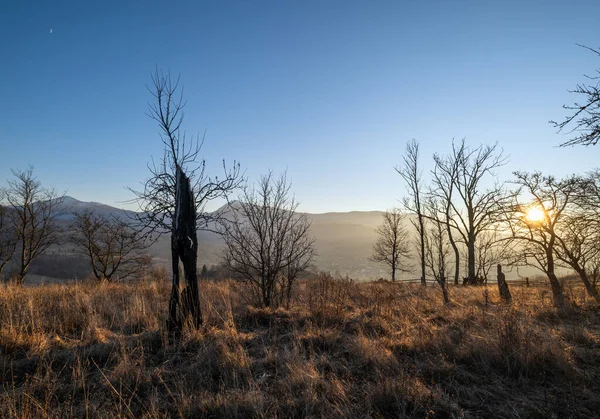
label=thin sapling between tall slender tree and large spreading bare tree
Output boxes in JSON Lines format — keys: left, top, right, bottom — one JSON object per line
{"left": 425, "top": 197, "right": 450, "bottom": 304}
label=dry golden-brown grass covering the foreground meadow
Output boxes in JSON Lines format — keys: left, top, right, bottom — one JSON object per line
{"left": 0, "top": 277, "right": 600, "bottom": 418}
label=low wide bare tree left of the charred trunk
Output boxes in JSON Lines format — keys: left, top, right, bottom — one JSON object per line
{"left": 71, "top": 210, "right": 152, "bottom": 282}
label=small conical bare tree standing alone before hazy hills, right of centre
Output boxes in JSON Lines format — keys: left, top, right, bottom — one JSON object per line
{"left": 370, "top": 208, "right": 411, "bottom": 281}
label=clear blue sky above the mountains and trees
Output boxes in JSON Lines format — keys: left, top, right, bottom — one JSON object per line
{"left": 0, "top": 0, "right": 600, "bottom": 212}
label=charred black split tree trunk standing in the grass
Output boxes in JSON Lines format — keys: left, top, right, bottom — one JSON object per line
{"left": 167, "top": 166, "right": 202, "bottom": 342}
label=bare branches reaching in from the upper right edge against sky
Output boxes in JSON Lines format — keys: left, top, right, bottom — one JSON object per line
{"left": 550, "top": 45, "right": 600, "bottom": 147}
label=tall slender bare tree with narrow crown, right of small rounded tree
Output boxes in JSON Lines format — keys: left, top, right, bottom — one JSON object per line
{"left": 395, "top": 139, "right": 427, "bottom": 285}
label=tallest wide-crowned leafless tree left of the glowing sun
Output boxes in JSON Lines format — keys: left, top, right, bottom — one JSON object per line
{"left": 439, "top": 140, "right": 508, "bottom": 284}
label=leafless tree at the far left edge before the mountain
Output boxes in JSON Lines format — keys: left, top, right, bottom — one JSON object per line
{"left": 5, "top": 167, "right": 64, "bottom": 284}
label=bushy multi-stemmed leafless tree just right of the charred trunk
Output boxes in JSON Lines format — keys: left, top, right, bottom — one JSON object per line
{"left": 222, "top": 172, "right": 315, "bottom": 307}
